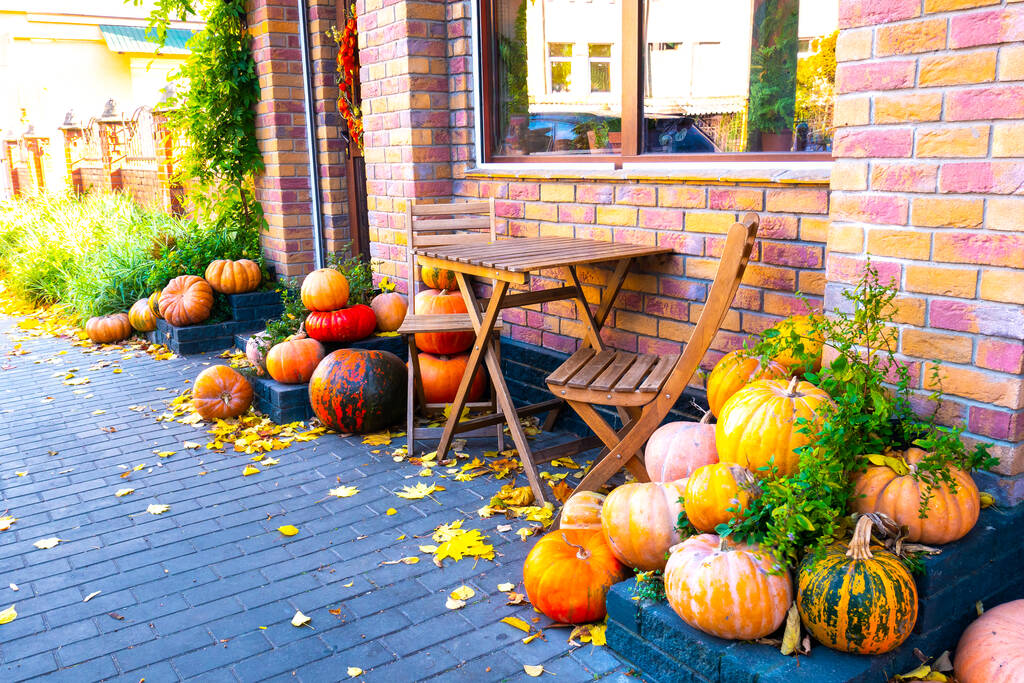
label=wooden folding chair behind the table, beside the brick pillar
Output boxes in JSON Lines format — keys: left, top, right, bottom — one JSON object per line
{"left": 398, "top": 199, "right": 505, "bottom": 456}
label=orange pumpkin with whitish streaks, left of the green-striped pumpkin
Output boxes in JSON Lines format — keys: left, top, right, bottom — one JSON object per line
{"left": 665, "top": 533, "right": 793, "bottom": 640}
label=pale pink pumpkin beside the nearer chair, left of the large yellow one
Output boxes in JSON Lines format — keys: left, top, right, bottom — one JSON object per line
{"left": 643, "top": 413, "right": 718, "bottom": 481}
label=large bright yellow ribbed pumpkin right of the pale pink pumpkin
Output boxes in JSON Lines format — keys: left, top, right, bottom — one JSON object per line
{"left": 715, "top": 377, "right": 831, "bottom": 477}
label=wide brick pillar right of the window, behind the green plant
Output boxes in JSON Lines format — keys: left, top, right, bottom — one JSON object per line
{"left": 826, "top": 0, "right": 1024, "bottom": 501}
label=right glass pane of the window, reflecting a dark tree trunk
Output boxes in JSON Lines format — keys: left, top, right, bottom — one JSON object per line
{"left": 641, "top": 0, "right": 839, "bottom": 154}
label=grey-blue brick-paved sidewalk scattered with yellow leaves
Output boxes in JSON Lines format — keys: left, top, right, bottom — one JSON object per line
{"left": 0, "top": 315, "right": 637, "bottom": 683}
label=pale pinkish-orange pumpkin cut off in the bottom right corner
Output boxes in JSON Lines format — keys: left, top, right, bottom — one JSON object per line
{"left": 953, "top": 600, "right": 1024, "bottom": 683}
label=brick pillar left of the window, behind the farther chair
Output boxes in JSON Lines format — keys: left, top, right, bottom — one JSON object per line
{"left": 356, "top": 0, "right": 452, "bottom": 292}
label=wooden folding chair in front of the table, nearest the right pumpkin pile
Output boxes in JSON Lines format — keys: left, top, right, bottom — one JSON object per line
{"left": 547, "top": 213, "right": 758, "bottom": 501}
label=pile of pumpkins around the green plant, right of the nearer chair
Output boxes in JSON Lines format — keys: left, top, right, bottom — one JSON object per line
{"left": 523, "top": 316, "right": 980, "bottom": 671}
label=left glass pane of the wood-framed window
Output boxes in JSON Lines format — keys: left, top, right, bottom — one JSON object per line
{"left": 488, "top": 0, "right": 623, "bottom": 157}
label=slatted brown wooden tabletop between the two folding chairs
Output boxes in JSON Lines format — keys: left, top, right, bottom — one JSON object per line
{"left": 415, "top": 238, "right": 672, "bottom": 272}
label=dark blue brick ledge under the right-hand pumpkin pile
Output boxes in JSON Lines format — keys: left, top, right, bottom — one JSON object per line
{"left": 607, "top": 506, "right": 1024, "bottom": 683}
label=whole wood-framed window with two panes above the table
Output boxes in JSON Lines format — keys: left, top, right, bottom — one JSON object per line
{"left": 480, "top": 0, "right": 839, "bottom": 163}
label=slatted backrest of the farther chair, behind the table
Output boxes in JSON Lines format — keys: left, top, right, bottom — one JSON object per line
{"left": 406, "top": 198, "right": 497, "bottom": 314}
